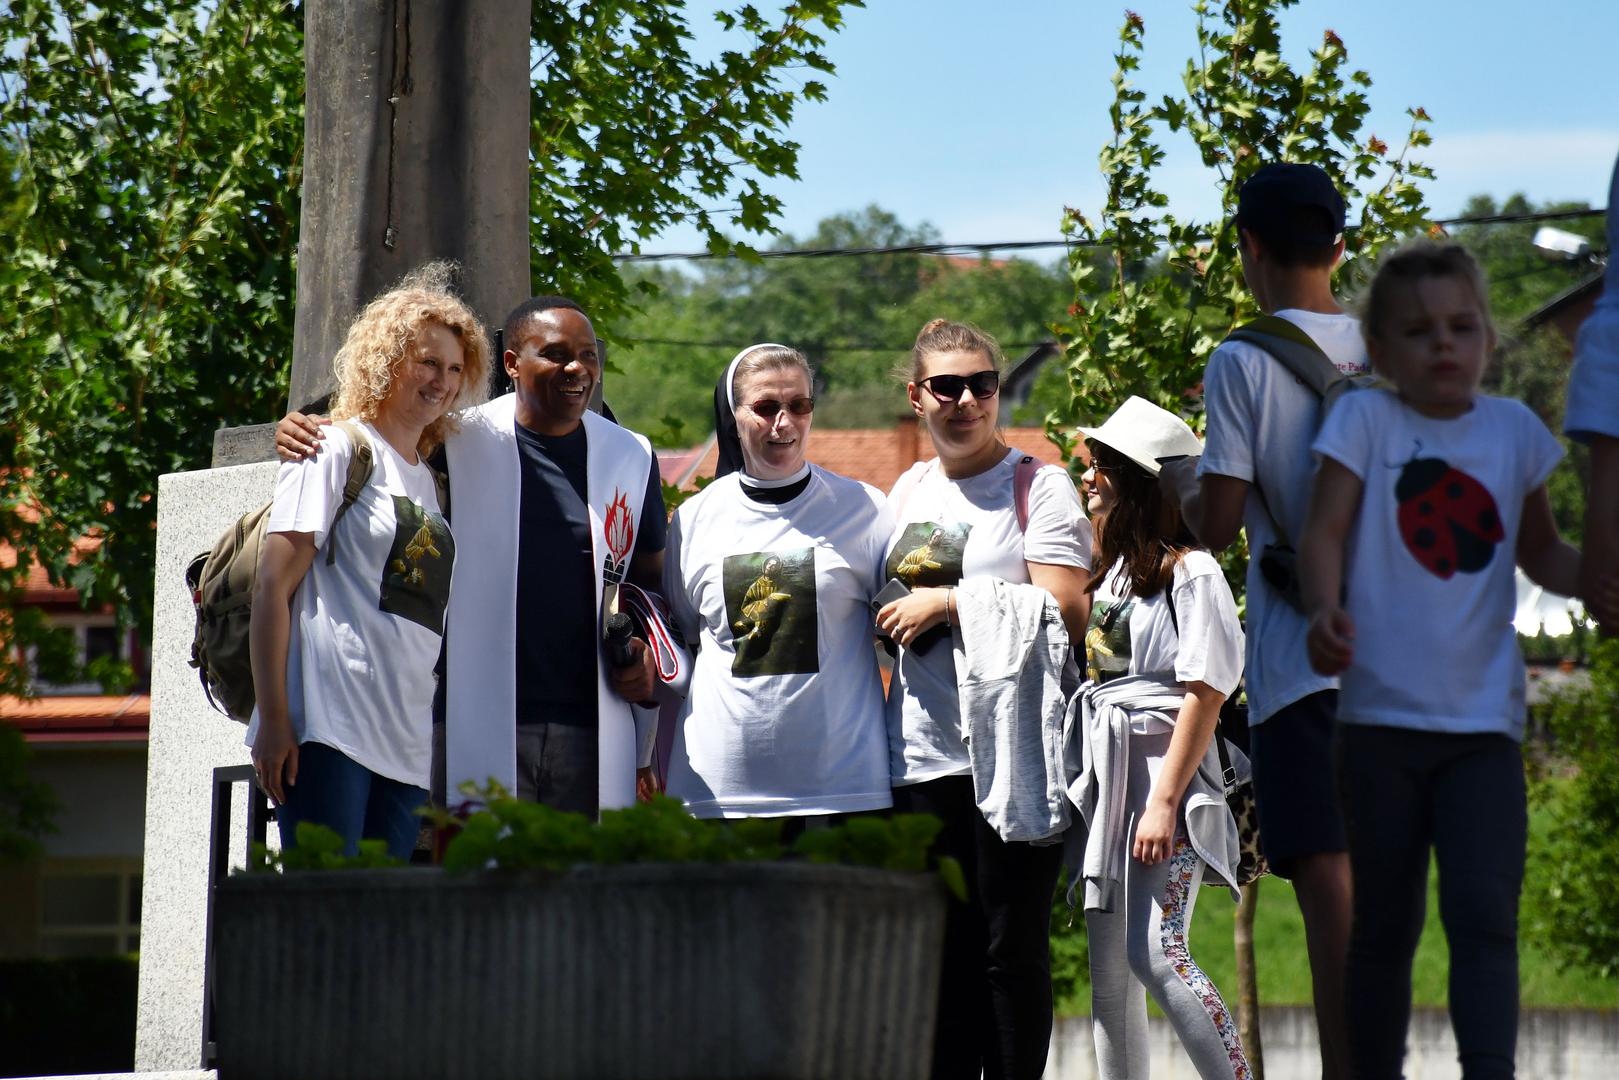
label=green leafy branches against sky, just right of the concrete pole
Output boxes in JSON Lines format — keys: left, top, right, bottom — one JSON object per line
{"left": 529, "top": 0, "right": 863, "bottom": 319}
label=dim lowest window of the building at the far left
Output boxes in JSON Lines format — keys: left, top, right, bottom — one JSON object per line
{"left": 39, "top": 863, "right": 141, "bottom": 957}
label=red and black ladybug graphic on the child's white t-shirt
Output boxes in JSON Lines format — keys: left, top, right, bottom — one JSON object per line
{"left": 1394, "top": 442, "right": 1506, "bottom": 581}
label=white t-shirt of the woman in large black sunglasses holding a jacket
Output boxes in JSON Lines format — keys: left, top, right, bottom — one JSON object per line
{"left": 882, "top": 449, "right": 1091, "bottom": 787}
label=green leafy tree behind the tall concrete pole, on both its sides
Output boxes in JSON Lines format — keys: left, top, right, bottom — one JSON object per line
{"left": 0, "top": 0, "right": 860, "bottom": 690}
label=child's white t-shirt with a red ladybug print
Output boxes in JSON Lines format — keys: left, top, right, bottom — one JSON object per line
{"left": 1315, "top": 390, "right": 1562, "bottom": 740}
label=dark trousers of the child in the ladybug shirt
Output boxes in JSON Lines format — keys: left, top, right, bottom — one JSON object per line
{"left": 1339, "top": 724, "right": 1528, "bottom": 1080}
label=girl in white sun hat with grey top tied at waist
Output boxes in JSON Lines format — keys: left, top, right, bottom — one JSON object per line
{"left": 1070, "top": 397, "right": 1250, "bottom": 1078}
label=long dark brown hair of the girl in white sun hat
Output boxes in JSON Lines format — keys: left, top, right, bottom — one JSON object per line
{"left": 1086, "top": 440, "right": 1198, "bottom": 599}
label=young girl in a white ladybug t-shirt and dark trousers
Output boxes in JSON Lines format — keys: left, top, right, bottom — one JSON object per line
{"left": 1300, "top": 241, "right": 1580, "bottom": 1080}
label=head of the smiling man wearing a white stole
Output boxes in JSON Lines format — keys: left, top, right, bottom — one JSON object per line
{"left": 505, "top": 308, "right": 602, "bottom": 436}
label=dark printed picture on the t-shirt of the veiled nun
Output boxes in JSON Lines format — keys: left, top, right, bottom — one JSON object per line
{"left": 720, "top": 547, "right": 821, "bottom": 678}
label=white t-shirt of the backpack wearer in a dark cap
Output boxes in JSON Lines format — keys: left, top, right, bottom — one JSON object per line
{"left": 1198, "top": 308, "right": 1370, "bottom": 724}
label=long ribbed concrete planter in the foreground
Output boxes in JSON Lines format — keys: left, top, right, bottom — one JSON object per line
{"left": 214, "top": 863, "right": 944, "bottom": 1080}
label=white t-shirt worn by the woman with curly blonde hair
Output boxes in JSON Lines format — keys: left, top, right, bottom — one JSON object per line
{"left": 248, "top": 424, "right": 455, "bottom": 787}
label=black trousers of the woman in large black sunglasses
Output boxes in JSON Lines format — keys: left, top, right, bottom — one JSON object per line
{"left": 894, "top": 776, "right": 1062, "bottom": 1080}
